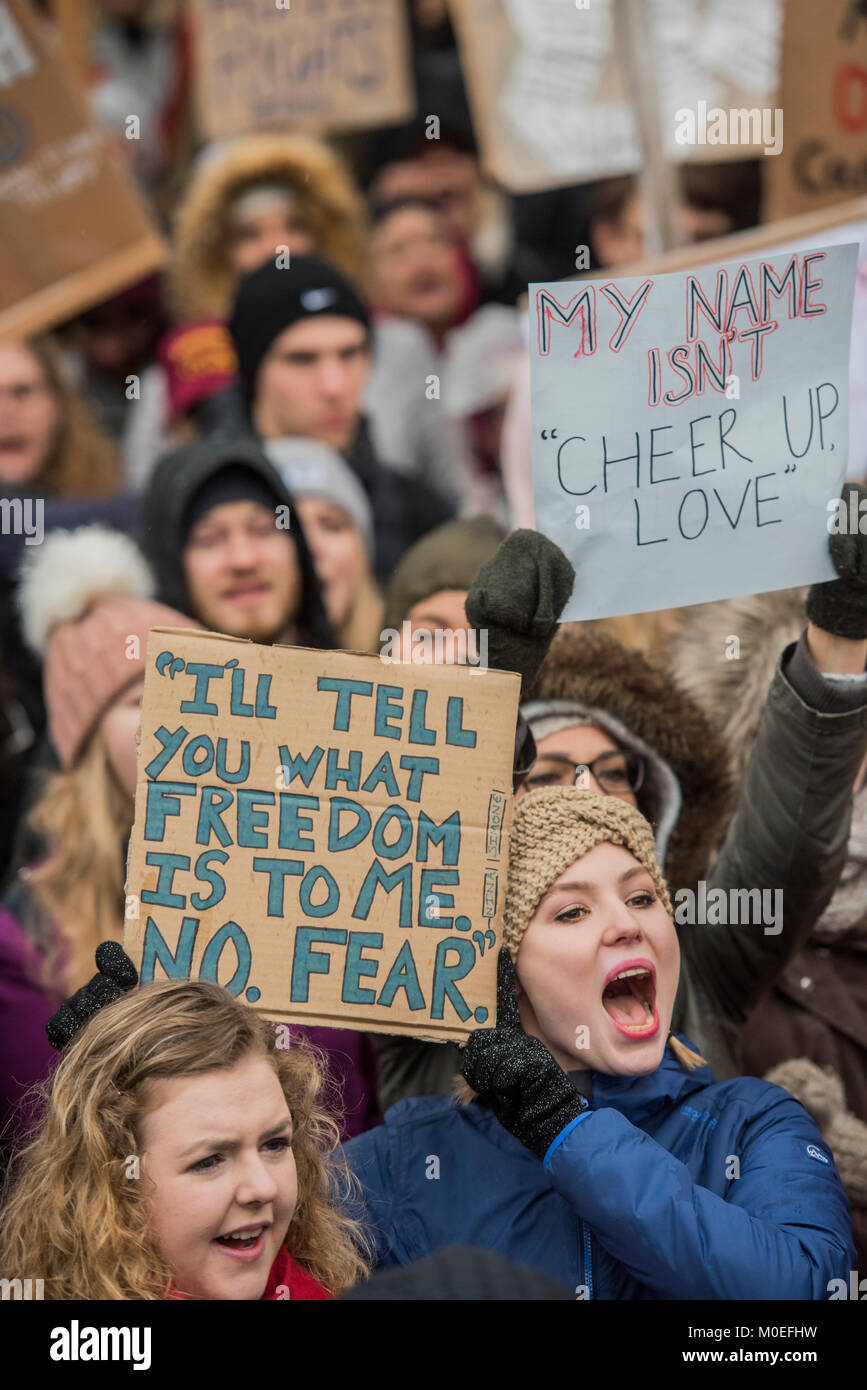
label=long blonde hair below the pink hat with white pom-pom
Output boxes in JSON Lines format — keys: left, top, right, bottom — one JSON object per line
{"left": 28, "top": 730, "right": 133, "bottom": 994}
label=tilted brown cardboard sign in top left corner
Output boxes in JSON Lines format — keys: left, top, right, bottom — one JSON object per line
{"left": 0, "top": 0, "right": 167, "bottom": 339}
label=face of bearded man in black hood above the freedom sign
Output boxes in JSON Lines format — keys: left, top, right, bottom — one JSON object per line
{"left": 183, "top": 502, "right": 303, "bottom": 642}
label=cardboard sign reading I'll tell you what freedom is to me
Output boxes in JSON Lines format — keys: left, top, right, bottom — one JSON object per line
{"left": 124, "top": 628, "right": 520, "bottom": 1040}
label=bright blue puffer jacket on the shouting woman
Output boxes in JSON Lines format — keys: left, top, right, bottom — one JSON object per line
{"left": 346, "top": 1051, "right": 854, "bottom": 1298}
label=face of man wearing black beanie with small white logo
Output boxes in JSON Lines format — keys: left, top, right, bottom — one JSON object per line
{"left": 253, "top": 314, "right": 370, "bottom": 452}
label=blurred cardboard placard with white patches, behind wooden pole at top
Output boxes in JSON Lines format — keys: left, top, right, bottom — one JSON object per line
{"left": 449, "top": 0, "right": 782, "bottom": 193}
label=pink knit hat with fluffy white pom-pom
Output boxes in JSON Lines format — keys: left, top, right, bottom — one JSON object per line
{"left": 18, "top": 525, "right": 197, "bottom": 769}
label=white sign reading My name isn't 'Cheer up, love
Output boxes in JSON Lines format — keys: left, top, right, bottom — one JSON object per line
{"left": 529, "top": 246, "right": 857, "bottom": 620}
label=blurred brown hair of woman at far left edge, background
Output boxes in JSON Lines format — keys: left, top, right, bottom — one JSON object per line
{"left": 21, "top": 336, "right": 121, "bottom": 498}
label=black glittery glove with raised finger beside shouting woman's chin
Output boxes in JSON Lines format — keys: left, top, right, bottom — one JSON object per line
{"left": 461, "top": 947, "right": 588, "bottom": 1158}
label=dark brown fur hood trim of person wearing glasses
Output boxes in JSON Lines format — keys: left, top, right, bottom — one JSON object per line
{"left": 528, "top": 623, "right": 732, "bottom": 891}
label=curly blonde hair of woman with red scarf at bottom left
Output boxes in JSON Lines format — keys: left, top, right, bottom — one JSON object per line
{"left": 0, "top": 981, "right": 370, "bottom": 1301}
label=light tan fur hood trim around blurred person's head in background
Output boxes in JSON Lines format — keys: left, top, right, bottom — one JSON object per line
{"left": 170, "top": 133, "right": 367, "bottom": 322}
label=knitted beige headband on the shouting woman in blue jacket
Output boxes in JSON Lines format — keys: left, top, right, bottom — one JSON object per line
{"left": 503, "top": 787, "right": 671, "bottom": 960}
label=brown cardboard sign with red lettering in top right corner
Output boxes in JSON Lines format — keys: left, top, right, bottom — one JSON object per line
{"left": 766, "top": 0, "right": 867, "bottom": 220}
